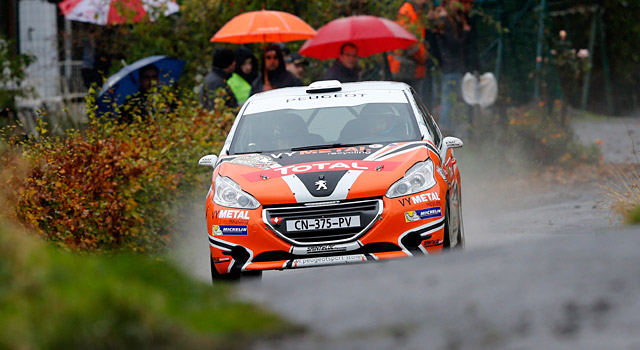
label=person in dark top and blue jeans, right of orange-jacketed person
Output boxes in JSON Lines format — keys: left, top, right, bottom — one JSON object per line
{"left": 435, "top": 0, "right": 471, "bottom": 131}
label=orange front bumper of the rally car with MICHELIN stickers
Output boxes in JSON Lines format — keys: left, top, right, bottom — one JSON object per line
{"left": 207, "top": 189, "right": 446, "bottom": 273}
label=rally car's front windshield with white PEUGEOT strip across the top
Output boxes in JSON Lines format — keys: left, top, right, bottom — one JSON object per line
{"left": 230, "top": 91, "right": 420, "bottom": 154}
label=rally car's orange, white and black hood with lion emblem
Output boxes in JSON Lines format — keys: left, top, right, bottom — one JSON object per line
{"left": 217, "top": 141, "right": 439, "bottom": 205}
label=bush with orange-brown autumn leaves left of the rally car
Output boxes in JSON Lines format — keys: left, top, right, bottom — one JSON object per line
{"left": 4, "top": 90, "right": 234, "bottom": 252}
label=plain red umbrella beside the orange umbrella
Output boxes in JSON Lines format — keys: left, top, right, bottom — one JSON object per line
{"left": 300, "top": 16, "right": 418, "bottom": 60}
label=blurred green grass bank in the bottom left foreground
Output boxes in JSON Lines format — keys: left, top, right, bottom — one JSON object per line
{"left": 0, "top": 217, "right": 296, "bottom": 349}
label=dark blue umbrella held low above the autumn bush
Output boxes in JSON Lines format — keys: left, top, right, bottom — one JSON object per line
{"left": 98, "top": 56, "right": 185, "bottom": 114}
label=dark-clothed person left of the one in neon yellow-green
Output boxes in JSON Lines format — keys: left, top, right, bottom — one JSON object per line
{"left": 200, "top": 48, "right": 238, "bottom": 110}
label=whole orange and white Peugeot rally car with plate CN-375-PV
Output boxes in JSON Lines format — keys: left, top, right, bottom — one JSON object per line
{"left": 200, "top": 81, "right": 464, "bottom": 280}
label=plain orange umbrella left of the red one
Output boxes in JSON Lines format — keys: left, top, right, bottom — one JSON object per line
{"left": 211, "top": 10, "right": 316, "bottom": 44}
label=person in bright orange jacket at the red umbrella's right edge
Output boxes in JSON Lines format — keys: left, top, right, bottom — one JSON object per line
{"left": 387, "top": 0, "right": 427, "bottom": 95}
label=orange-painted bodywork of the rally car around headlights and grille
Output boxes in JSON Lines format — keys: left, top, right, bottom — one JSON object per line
{"left": 206, "top": 142, "right": 460, "bottom": 273}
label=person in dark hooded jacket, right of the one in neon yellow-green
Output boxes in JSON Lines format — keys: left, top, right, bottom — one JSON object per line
{"left": 251, "top": 45, "right": 302, "bottom": 95}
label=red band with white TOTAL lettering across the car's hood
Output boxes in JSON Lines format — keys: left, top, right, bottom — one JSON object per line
{"left": 243, "top": 160, "right": 400, "bottom": 182}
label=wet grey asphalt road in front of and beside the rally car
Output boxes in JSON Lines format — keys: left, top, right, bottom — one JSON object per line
{"left": 176, "top": 116, "right": 640, "bottom": 350}
